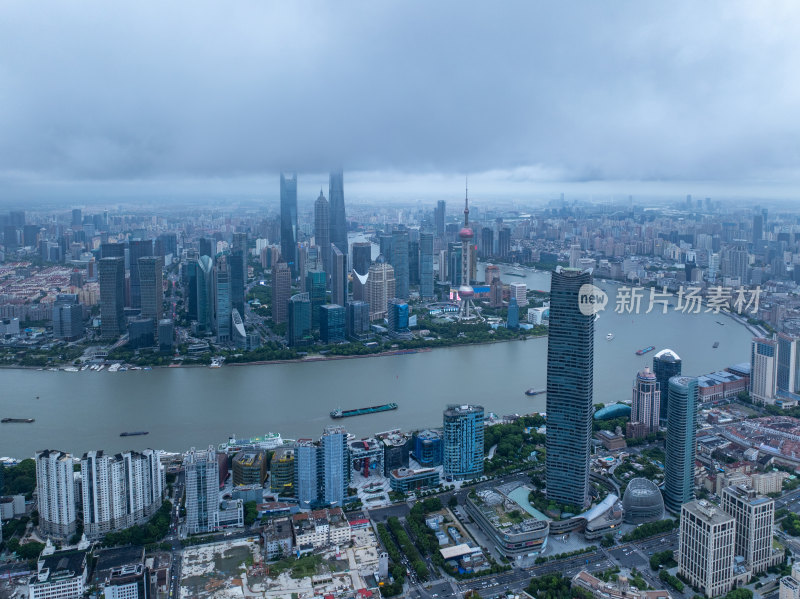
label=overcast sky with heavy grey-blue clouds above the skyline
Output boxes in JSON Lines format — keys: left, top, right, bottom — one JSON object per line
{"left": 0, "top": 0, "right": 800, "bottom": 202}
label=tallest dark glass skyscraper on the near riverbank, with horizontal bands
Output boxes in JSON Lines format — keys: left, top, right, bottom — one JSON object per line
{"left": 546, "top": 267, "right": 594, "bottom": 508}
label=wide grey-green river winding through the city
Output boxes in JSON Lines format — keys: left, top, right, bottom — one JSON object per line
{"left": 0, "top": 265, "right": 751, "bottom": 458}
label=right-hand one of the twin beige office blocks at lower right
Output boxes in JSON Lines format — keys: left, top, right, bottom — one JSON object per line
{"left": 721, "top": 485, "right": 775, "bottom": 574}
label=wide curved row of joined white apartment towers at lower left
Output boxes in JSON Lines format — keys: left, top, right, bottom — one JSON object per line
{"left": 81, "top": 449, "right": 166, "bottom": 539}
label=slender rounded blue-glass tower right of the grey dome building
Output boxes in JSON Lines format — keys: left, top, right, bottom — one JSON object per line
{"left": 664, "top": 378, "right": 698, "bottom": 514}
